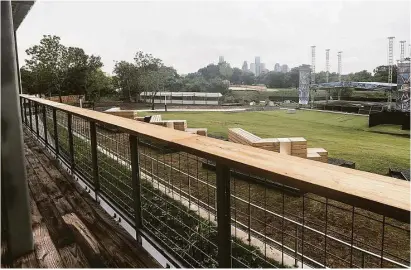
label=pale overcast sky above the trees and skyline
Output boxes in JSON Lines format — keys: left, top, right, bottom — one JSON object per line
{"left": 17, "top": 1, "right": 410, "bottom": 74}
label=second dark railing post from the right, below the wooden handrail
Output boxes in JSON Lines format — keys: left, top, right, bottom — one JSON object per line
{"left": 129, "top": 135, "right": 142, "bottom": 243}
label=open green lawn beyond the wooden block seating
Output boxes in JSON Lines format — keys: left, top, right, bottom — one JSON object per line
{"left": 147, "top": 110, "right": 410, "bottom": 174}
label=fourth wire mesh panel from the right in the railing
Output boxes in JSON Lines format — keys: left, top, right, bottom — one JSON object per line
{"left": 72, "top": 116, "right": 93, "bottom": 183}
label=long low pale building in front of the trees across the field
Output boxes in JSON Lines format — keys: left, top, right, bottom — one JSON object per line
{"left": 140, "top": 92, "right": 222, "bottom": 105}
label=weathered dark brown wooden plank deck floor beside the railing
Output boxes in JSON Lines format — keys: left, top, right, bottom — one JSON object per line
{"left": 2, "top": 130, "right": 161, "bottom": 268}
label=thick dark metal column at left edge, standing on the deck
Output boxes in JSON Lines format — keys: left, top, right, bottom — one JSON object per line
{"left": 0, "top": 1, "right": 33, "bottom": 258}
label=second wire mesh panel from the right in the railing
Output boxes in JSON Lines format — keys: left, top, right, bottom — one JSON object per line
{"left": 138, "top": 137, "right": 218, "bottom": 268}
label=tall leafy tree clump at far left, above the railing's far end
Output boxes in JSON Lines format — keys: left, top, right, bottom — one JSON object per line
{"left": 21, "top": 35, "right": 112, "bottom": 98}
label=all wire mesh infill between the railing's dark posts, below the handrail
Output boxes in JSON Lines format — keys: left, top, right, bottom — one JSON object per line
{"left": 24, "top": 97, "right": 410, "bottom": 268}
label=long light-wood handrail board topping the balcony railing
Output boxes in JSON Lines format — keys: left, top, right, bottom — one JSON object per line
{"left": 20, "top": 95, "right": 410, "bottom": 223}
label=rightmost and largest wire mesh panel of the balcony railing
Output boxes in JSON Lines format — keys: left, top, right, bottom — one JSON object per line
{"left": 231, "top": 167, "right": 410, "bottom": 268}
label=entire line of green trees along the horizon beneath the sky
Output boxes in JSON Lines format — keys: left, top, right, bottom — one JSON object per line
{"left": 20, "top": 35, "right": 397, "bottom": 106}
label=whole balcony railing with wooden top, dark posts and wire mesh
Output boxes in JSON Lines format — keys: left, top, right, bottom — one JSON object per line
{"left": 20, "top": 95, "right": 410, "bottom": 268}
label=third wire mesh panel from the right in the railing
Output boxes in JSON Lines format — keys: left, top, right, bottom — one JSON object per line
{"left": 96, "top": 125, "right": 134, "bottom": 216}
